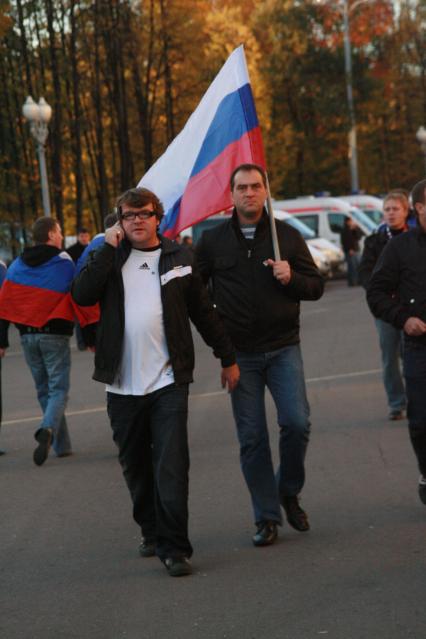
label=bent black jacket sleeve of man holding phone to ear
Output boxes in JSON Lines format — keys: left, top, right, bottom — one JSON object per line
{"left": 71, "top": 243, "right": 117, "bottom": 306}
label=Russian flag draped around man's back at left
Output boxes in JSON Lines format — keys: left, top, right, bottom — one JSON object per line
{"left": 0, "top": 252, "right": 99, "bottom": 328}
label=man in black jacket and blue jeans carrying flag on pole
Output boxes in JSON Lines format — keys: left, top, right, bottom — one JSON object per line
{"left": 196, "top": 164, "right": 324, "bottom": 546}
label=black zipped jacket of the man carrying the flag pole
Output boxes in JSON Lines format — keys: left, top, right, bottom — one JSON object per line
{"left": 196, "top": 211, "right": 324, "bottom": 352}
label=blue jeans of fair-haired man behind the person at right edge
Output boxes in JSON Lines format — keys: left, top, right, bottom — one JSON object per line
{"left": 376, "top": 319, "right": 407, "bottom": 411}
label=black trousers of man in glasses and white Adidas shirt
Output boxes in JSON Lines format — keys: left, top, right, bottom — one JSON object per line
{"left": 107, "top": 384, "right": 192, "bottom": 559}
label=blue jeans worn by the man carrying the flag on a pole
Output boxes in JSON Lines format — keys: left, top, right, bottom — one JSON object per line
{"left": 232, "top": 344, "right": 310, "bottom": 523}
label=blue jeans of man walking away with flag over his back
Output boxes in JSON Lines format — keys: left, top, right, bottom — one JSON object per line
{"left": 21, "top": 333, "right": 71, "bottom": 455}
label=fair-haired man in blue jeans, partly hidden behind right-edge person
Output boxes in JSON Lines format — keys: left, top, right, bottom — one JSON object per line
{"left": 358, "top": 191, "right": 409, "bottom": 421}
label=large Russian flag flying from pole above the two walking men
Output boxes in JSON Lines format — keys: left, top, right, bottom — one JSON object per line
{"left": 138, "top": 46, "right": 265, "bottom": 237}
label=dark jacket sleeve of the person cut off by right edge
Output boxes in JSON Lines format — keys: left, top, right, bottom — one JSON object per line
{"left": 367, "top": 240, "right": 410, "bottom": 329}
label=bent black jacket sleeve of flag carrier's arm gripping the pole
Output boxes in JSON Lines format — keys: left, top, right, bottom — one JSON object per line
{"left": 282, "top": 233, "right": 324, "bottom": 301}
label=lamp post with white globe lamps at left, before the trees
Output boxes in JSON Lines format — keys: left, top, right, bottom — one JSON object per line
{"left": 22, "top": 96, "right": 52, "bottom": 217}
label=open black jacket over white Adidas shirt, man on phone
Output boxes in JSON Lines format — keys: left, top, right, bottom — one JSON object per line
{"left": 71, "top": 237, "right": 235, "bottom": 384}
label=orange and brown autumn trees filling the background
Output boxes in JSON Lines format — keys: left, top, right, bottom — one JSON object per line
{"left": 0, "top": 0, "right": 426, "bottom": 248}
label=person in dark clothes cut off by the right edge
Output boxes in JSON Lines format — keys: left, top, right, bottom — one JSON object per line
{"left": 367, "top": 179, "right": 426, "bottom": 504}
